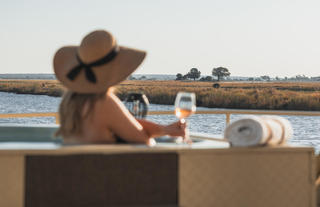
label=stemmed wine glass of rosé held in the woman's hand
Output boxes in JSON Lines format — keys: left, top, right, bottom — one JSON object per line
{"left": 174, "top": 92, "right": 196, "bottom": 140}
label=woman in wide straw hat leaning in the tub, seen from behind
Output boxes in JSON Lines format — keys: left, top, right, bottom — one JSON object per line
{"left": 54, "top": 30, "right": 186, "bottom": 145}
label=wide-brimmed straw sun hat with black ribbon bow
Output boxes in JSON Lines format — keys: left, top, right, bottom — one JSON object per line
{"left": 53, "top": 30, "right": 146, "bottom": 93}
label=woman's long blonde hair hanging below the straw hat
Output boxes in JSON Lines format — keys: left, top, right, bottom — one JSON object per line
{"left": 56, "top": 91, "right": 106, "bottom": 138}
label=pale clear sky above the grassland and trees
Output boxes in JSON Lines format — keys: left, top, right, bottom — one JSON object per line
{"left": 0, "top": 0, "right": 320, "bottom": 77}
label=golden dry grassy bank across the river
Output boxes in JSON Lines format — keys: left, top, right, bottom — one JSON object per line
{"left": 0, "top": 80, "right": 320, "bottom": 111}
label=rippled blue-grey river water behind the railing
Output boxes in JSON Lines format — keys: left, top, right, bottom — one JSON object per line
{"left": 0, "top": 92, "right": 320, "bottom": 152}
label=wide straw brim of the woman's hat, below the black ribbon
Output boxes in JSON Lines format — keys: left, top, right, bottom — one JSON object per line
{"left": 53, "top": 46, "right": 146, "bottom": 93}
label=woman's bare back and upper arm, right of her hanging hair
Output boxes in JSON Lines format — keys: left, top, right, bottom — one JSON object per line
{"left": 66, "top": 92, "right": 147, "bottom": 143}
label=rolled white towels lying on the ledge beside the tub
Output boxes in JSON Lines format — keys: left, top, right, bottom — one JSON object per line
{"left": 224, "top": 116, "right": 293, "bottom": 147}
